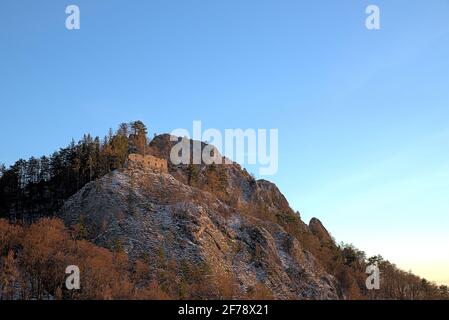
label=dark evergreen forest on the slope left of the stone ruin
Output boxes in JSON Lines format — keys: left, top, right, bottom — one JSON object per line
{"left": 0, "top": 121, "right": 147, "bottom": 222}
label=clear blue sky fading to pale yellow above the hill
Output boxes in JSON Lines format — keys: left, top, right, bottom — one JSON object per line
{"left": 0, "top": 0, "right": 449, "bottom": 284}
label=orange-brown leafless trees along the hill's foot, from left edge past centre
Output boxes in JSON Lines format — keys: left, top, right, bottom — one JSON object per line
{"left": 0, "top": 218, "right": 252, "bottom": 300}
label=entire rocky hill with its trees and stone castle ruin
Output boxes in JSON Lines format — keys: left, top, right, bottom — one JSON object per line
{"left": 0, "top": 121, "right": 449, "bottom": 300}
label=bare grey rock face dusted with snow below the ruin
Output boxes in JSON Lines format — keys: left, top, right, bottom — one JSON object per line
{"left": 60, "top": 134, "right": 339, "bottom": 299}
